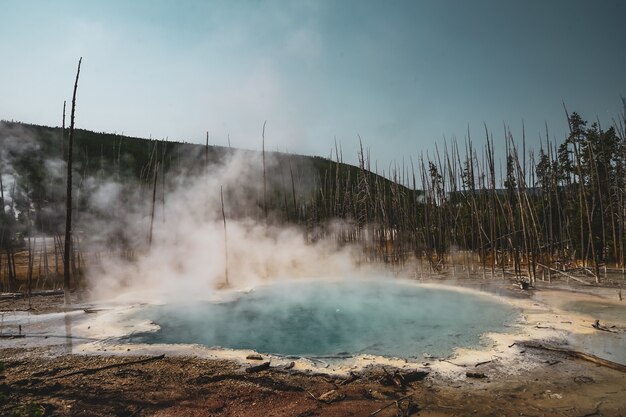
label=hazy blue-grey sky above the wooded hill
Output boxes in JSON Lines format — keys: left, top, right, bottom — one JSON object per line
{"left": 0, "top": 0, "right": 626, "bottom": 171}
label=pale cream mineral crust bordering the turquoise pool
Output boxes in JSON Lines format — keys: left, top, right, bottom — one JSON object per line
{"left": 1, "top": 280, "right": 626, "bottom": 378}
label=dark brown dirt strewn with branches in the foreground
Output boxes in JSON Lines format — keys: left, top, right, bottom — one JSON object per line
{"left": 0, "top": 286, "right": 626, "bottom": 417}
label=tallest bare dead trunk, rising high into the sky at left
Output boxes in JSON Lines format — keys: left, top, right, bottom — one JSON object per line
{"left": 63, "top": 57, "right": 83, "bottom": 305}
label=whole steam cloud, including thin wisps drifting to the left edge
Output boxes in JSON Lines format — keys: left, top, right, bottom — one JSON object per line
{"left": 0, "top": 123, "right": 370, "bottom": 299}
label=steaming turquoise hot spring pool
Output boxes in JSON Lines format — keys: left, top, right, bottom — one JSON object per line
{"left": 125, "top": 279, "right": 517, "bottom": 358}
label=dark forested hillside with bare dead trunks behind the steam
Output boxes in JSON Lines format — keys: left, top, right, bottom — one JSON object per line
{"left": 0, "top": 103, "right": 626, "bottom": 288}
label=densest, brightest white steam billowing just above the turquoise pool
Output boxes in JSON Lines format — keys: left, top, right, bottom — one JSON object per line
{"left": 82, "top": 152, "right": 364, "bottom": 300}
